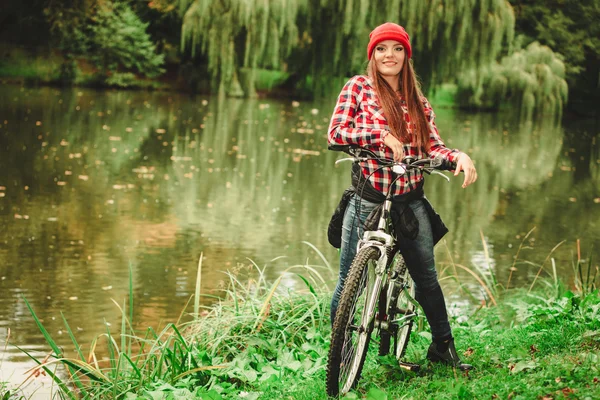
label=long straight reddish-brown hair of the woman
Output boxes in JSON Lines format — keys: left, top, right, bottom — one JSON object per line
{"left": 367, "top": 55, "right": 431, "bottom": 152}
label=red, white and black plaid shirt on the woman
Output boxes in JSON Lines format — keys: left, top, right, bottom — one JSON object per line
{"left": 328, "top": 75, "right": 459, "bottom": 195}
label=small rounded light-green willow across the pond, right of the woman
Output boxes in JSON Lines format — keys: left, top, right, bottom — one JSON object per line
{"left": 457, "top": 42, "right": 568, "bottom": 119}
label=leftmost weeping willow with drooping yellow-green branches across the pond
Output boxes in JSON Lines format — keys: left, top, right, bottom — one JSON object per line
{"left": 179, "top": 0, "right": 309, "bottom": 96}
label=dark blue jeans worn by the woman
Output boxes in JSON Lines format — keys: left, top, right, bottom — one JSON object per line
{"left": 331, "top": 195, "right": 452, "bottom": 341}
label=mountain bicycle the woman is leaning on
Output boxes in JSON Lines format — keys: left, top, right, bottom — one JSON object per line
{"left": 327, "top": 147, "right": 455, "bottom": 396}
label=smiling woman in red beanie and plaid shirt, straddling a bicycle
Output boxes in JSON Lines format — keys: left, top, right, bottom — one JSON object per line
{"left": 328, "top": 22, "right": 477, "bottom": 370}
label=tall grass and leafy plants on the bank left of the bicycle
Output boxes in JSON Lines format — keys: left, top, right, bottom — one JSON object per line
{"left": 19, "top": 258, "right": 329, "bottom": 399}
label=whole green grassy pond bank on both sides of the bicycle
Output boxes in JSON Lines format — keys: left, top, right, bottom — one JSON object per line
{"left": 0, "top": 258, "right": 600, "bottom": 400}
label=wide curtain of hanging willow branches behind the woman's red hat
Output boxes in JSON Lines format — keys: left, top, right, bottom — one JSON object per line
{"left": 179, "top": 0, "right": 515, "bottom": 95}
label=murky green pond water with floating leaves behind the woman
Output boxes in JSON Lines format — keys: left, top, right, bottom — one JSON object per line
{"left": 0, "top": 85, "right": 600, "bottom": 393}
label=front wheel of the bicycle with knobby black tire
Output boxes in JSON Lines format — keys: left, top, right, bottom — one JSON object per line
{"left": 326, "top": 247, "right": 380, "bottom": 396}
